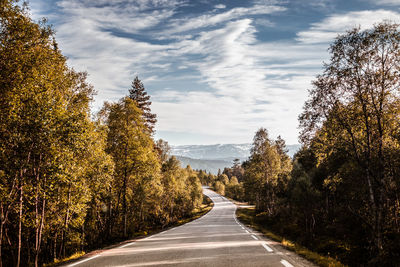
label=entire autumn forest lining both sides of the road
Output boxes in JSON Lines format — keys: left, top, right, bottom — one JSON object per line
{"left": 0, "top": 0, "right": 400, "bottom": 266}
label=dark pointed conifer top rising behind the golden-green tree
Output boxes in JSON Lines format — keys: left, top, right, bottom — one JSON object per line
{"left": 129, "top": 76, "right": 157, "bottom": 133}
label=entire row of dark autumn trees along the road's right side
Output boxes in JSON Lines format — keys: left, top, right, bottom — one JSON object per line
{"left": 212, "top": 23, "right": 400, "bottom": 266}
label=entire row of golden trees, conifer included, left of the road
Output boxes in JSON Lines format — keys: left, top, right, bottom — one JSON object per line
{"left": 0, "top": 0, "right": 202, "bottom": 266}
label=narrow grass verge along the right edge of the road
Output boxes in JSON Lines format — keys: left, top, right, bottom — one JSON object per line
{"left": 236, "top": 208, "right": 346, "bottom": 267}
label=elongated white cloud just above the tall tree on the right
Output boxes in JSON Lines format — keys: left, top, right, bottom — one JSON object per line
{"left": 297, "top": 10, "right": 400, "bottom": 44}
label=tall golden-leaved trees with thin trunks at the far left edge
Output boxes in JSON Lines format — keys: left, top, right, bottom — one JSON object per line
{"left": 0, "top": 1, "right": 112, "bottom": 265}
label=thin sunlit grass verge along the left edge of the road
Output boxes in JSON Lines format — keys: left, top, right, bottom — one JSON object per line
{"left": 47, "top": 195, "right": 214, "bottom": 267}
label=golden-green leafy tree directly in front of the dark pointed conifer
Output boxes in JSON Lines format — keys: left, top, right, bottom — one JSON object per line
{"left": 103, "top": 97, "right": 162, "bottom": 237}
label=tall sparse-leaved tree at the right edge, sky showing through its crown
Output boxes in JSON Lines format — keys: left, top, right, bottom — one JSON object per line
{"left": 299, "top": 23, "right": 400, "bottom": 265}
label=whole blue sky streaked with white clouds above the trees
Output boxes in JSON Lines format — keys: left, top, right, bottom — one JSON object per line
{"left": 30, "top": 0, "right": 400, "bottom": 145}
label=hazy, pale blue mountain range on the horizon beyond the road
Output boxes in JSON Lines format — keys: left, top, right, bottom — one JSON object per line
{"left": 171, "top": 144, "right": 300, "bottom": 174}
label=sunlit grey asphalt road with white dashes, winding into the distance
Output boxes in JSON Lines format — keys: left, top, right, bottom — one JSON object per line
{"left": 67, "top": 189, "right": 314, "bottom": 267}
